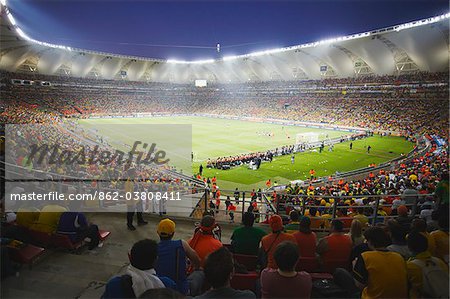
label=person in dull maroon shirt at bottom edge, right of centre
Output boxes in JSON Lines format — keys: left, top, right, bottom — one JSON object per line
{"left": 260, "top": 242, "right": 312, "bottom": 298}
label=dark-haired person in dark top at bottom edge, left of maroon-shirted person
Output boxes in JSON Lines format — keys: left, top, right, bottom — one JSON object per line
{"left": 194, "top": 247, "right": 256, "bottom": 299}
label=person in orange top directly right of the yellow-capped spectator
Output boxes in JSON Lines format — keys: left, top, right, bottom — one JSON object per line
{"left": 188, "top": 215, "right": 222, "bottom": 266}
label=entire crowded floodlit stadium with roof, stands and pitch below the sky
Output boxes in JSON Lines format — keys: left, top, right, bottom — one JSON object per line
{"left": 0, "top": 0, "right": 450, "bottom": 298}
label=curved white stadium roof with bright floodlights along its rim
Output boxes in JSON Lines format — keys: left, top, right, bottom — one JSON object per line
{"left": 0, "top": 0, "right": 450, "bottom": 83}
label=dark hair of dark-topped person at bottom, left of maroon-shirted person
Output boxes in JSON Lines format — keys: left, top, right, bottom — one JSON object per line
{"left": 203, "top": 247, "right": 234, "bottom": 289}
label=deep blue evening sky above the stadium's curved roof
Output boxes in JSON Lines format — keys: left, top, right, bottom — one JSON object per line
{"left": 8, "top": 0, "right": 449, "bottom": 60}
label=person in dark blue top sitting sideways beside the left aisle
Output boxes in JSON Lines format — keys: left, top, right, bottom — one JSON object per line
{"left": 57, "top": 212, "right": 100, "bottom": 250}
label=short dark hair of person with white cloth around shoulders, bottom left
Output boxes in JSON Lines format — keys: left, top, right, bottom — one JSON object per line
{"left": 130, "top": 239, "right": 158, "bottom": 270}
